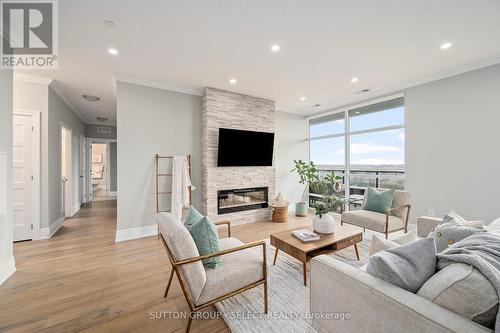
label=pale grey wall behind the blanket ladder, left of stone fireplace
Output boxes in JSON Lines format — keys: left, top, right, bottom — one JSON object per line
{"left": 117, "top": 82, "right": 201, "bottom": 230}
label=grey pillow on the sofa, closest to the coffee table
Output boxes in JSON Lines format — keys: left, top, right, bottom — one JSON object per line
{"left": 366, "top": 238, "right": 436, "bottom": 293}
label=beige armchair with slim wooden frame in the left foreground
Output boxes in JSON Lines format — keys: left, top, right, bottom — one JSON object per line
{"left": 156, "top": 213, "right": 268, "bottom": 332}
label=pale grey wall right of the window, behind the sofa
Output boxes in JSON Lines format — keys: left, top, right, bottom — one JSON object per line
{"left": 405, "top": 65, "right": 500, "bottom": 222}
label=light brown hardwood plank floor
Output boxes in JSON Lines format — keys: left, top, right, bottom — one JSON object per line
{"left": 0, "top": 201, "right": 308, "bottom": 333}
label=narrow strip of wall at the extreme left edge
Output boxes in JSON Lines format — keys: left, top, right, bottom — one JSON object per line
{"left": 0, "top": 68, "right": 14, "bottom": 284}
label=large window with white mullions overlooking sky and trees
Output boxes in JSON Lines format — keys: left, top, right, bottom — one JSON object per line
{"left": 310, "top": 97, "right": 405, "bottom": 208}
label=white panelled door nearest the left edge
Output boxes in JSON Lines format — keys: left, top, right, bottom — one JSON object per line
{"left": 12, "top": 114, "right": 34, "bottom": 241}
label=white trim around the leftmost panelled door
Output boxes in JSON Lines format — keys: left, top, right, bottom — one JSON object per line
{"left": 13, "top": 108, "right": 42, "bottom": 240}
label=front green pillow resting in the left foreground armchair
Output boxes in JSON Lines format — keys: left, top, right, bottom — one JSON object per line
{"left": 186, "top": 217, "right": 220, "bottom": 268}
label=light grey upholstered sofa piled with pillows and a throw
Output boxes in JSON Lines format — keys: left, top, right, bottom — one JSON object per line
{"left": 310, "top": 217, "right": 500, "bottom": 333}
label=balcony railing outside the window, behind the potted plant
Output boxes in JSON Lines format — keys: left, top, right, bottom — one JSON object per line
{"left": 309, "top": 169, "right": 405, "bottom": 209}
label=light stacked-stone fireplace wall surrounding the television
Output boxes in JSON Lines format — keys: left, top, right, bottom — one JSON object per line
{"left": 202, "top": 88, "right": 276, "bottom": 224}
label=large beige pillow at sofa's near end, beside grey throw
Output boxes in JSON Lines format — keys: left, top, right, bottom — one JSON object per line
{"left": 417, "top": 263, "right": 498, "bottom": 329}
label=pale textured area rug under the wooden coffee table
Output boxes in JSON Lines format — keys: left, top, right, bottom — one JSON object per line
{"left": 216, "top": 239, "right": 370, "bottom": 333}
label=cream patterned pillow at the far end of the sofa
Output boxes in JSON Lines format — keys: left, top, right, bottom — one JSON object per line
{"left": 428, "top": 215, "right": 486, "bottom": 253}
